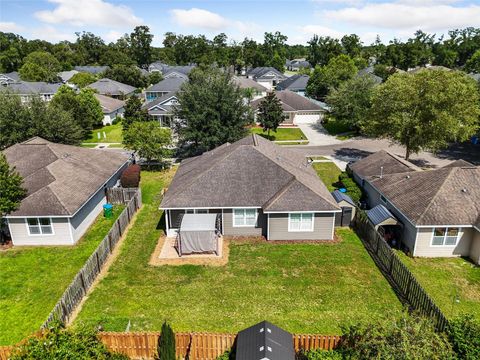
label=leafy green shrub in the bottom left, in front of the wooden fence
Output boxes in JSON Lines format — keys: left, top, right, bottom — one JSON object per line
{"left": 10, "top": 324, "right": 128, "bottom": 360}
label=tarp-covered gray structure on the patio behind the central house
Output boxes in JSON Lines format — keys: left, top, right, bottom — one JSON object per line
{"left": 179, "top": 214, "right": 218, "bottom": 255}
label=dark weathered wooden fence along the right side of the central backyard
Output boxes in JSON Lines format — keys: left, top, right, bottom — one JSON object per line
{"left": 353, "top": 211, "right": 448, "bottom": 331}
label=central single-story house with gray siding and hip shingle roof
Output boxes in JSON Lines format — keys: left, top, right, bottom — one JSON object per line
{"left": 160, "top": 134, "right": 341, "bottom": 240}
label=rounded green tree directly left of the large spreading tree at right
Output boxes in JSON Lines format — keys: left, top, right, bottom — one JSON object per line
{"left": 326, "top": 75, "right": 376, "bottom": 131}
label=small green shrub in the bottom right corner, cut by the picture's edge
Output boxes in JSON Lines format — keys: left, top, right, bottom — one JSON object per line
{"left": 447, "top": 315, "right": 480, "bottom": 360}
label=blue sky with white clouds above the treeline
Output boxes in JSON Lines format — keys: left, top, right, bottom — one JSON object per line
{"left": 0, "top": 0, "right": 480, "bottom": 46}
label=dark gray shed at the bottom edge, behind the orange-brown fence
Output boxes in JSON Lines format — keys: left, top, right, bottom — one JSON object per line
{"left": 235, "top": 321, "right": 295, "bottom": 360}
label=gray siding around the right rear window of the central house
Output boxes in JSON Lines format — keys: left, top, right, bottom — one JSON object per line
{"left": 268, "top": 213, "right": 335, "bottom": 240}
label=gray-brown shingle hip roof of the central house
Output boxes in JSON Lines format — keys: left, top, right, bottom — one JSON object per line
{"left": 161, "top": 135, "right": 339, "bottom": 212}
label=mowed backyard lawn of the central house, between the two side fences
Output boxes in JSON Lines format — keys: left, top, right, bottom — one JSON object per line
{"left": 75, "top": 171, "right": 401, "bottom": 334}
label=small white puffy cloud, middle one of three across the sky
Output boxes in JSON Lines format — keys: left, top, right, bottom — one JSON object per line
{"left": 170, "top": 8, "right": 229, "bottom": 30}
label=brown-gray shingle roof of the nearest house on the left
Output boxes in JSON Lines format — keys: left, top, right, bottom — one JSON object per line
{"left": 3, "top": 137, "right": 128, "bottom": 216}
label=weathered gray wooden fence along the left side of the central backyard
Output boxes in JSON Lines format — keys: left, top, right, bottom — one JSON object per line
{"left": 42, "top": 189, "right": 142, "bottom": 328}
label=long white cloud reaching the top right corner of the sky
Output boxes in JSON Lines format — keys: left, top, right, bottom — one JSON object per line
{"left": 322, "top": 0, "right": 480, "bottom": 31}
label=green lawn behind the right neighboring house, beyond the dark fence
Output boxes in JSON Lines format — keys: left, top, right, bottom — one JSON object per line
{"left": 397, "top": 251, "right": 480, "bottom": 319}
